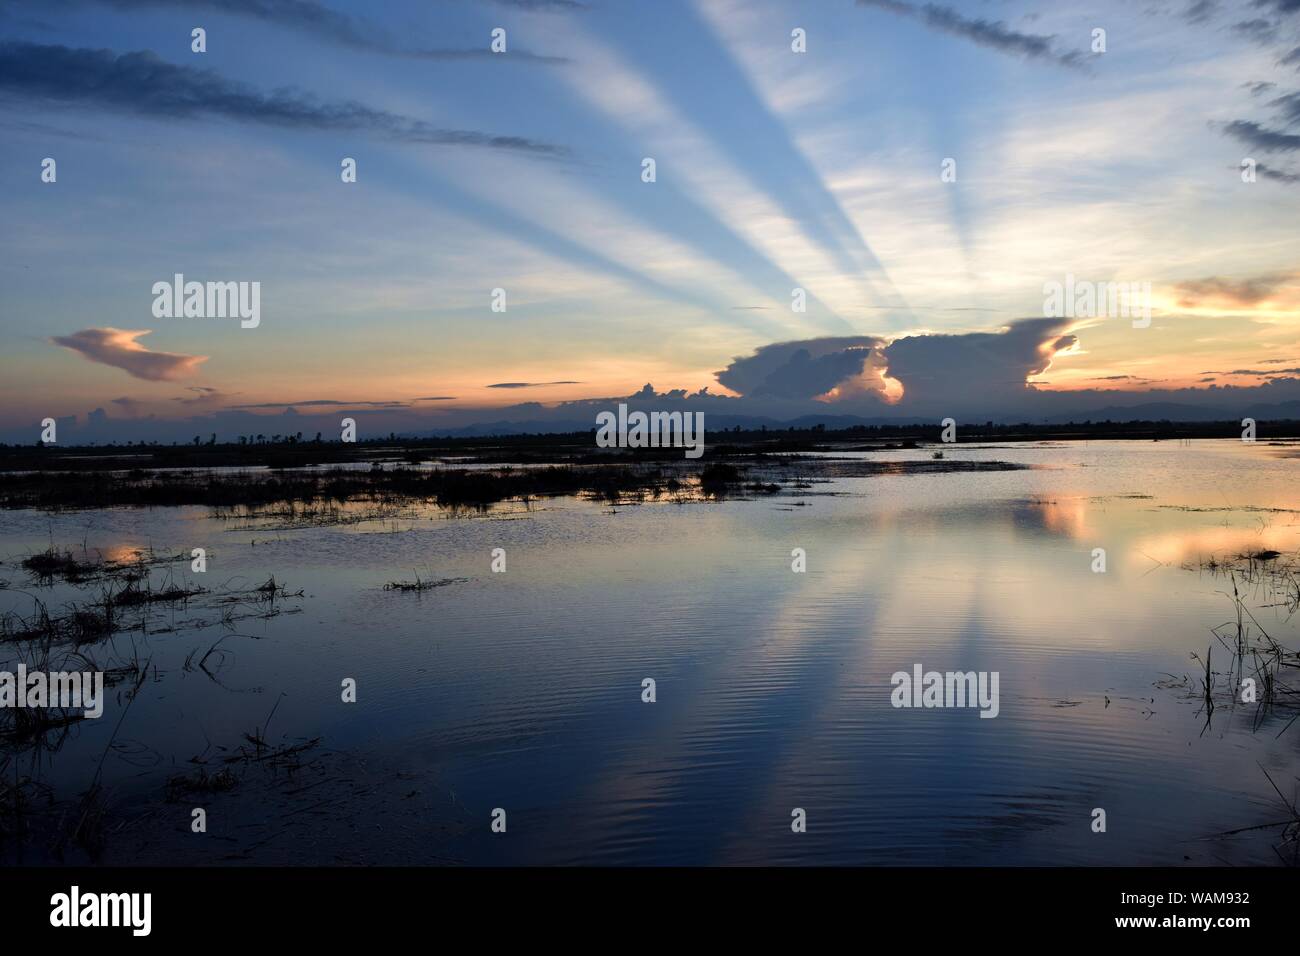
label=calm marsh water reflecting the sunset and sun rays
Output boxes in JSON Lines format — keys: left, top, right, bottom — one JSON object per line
{"left": 0, "top": 441, "right": 1300, "bottom": 865}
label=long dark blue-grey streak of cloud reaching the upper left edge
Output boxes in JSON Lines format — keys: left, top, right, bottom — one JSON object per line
{"left": 0, "top": 42, "right": 567, "bottom": 156}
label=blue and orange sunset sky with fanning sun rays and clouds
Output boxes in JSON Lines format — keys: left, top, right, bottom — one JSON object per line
{"left": 0, "top": 0, "right": 1300, "bottom": 442}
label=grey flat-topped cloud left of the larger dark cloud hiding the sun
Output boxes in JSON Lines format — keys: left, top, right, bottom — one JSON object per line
{"left": 715, "top": 336, "right": 885, "bottom": 399}
